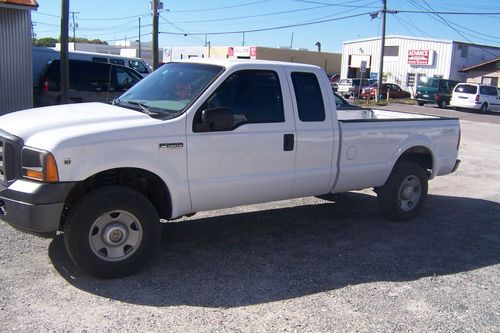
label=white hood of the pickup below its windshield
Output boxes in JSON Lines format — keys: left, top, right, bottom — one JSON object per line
{"left": 0, "top": 103, "right": 159, "bottom": 149}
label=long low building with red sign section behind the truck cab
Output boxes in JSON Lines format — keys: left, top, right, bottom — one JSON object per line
{"left": 163, "top": 46, "right": 342, "bottom": 75}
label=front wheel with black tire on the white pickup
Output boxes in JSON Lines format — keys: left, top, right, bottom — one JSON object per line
{"left": 64, "top": 186, "right": 161, "bottom": 278}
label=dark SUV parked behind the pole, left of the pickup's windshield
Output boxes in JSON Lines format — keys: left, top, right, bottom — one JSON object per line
{"left": 34, "top": 59, "right": 142, "bottom": 107}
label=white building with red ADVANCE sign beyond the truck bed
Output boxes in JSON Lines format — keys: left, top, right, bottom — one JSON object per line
{"left": 341, "top": 36, "right": 500, "bottom": 92}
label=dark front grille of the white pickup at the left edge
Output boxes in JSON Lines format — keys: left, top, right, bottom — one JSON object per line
{"left": 0, "top": 130, "right": 22, "bottom": 186}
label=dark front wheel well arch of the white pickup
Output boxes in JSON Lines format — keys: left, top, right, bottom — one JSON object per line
{"left": 62, "top": 168, "right": 172, "bottom": 223}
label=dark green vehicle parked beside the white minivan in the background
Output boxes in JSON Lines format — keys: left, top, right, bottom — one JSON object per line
{"left": 415, "top": 78, "right": 459, "bottom": 108}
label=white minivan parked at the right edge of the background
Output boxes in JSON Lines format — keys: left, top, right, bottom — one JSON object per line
{"left": 450, "top": 83, "right": 500, "bottom": 113}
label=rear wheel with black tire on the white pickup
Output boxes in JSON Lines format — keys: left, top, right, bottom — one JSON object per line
{"left": 376, "top": 161, "right": 428, "bottom": 221}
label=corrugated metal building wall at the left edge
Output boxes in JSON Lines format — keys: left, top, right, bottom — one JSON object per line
{"left": 0, "top": 0, "right": 38, "bottom": 115}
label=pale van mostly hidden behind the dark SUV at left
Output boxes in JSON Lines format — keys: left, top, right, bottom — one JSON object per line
{"left": 32, "top": 46, "right": 152, "bottom": 87}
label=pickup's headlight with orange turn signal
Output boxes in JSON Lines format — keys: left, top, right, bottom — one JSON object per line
{"left": 21, "top": 147, "right": 59, "bottom": 183}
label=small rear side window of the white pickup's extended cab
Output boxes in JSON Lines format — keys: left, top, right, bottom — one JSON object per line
{"left": 292, "top": 72, "right": 325, "bottom": 122}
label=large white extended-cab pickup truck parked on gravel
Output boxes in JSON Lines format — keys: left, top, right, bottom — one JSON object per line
{"left": 0, "top": 60, "right": 460, "bottom": 277}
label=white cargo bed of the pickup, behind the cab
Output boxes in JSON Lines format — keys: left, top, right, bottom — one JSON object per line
{"left": 333, "top": 109, "right": 460, "bottom": 192}
